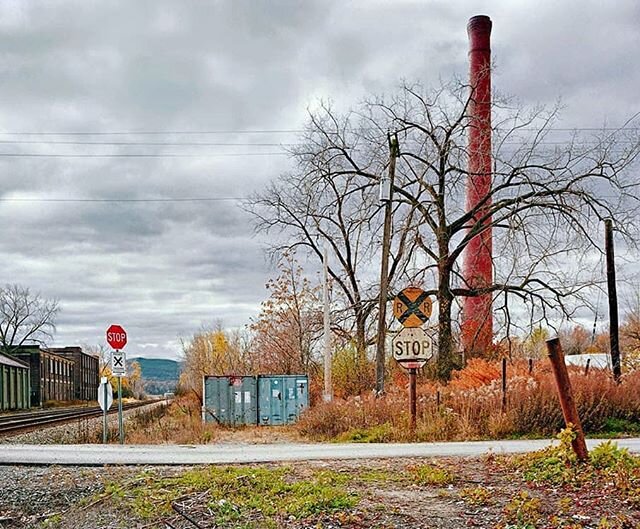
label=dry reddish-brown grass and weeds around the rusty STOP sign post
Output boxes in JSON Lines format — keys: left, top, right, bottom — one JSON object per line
{"left": 297, "top": 361, "right": 640, "bottom": 442}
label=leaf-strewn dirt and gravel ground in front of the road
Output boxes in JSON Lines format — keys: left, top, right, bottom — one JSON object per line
{"left": 0, "top": 456, "right": 640, "bottom": 529}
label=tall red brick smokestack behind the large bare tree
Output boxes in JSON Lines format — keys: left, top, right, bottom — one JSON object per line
{"left": 462, "top": 15, "right": 493, "bottom": 357}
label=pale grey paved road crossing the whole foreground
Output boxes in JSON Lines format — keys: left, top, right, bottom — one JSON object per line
{"left": 0, "top": 438, "right": 640, "bottom": 466}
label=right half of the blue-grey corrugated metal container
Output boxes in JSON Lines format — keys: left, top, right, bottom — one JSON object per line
{"left": 258, "top": 375, "right": 309, "bottom": 426}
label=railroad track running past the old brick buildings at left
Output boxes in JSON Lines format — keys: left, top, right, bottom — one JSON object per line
{"left": 0, "top": 400, "right": 158, "bottom": 436}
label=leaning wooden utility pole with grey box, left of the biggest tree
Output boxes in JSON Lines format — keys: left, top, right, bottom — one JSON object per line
{"left": 376, "top": 134, "right": 400, "bottom": 395}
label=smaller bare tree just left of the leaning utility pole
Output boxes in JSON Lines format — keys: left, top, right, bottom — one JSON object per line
{"left": 246, "top": 105, "right": 416, "bottom": 358}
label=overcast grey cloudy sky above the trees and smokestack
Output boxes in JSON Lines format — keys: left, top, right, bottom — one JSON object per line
{"left": 0, "top": 0, "right": 640, "bottom": 357}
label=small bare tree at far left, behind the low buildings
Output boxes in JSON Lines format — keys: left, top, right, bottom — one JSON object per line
{"left": 0, "top": 285, "right": 60, "bottom": 353}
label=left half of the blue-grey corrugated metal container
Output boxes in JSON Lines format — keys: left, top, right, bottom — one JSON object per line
{"left": 202, "top": 376, "right": 258, "bottom": 426}
